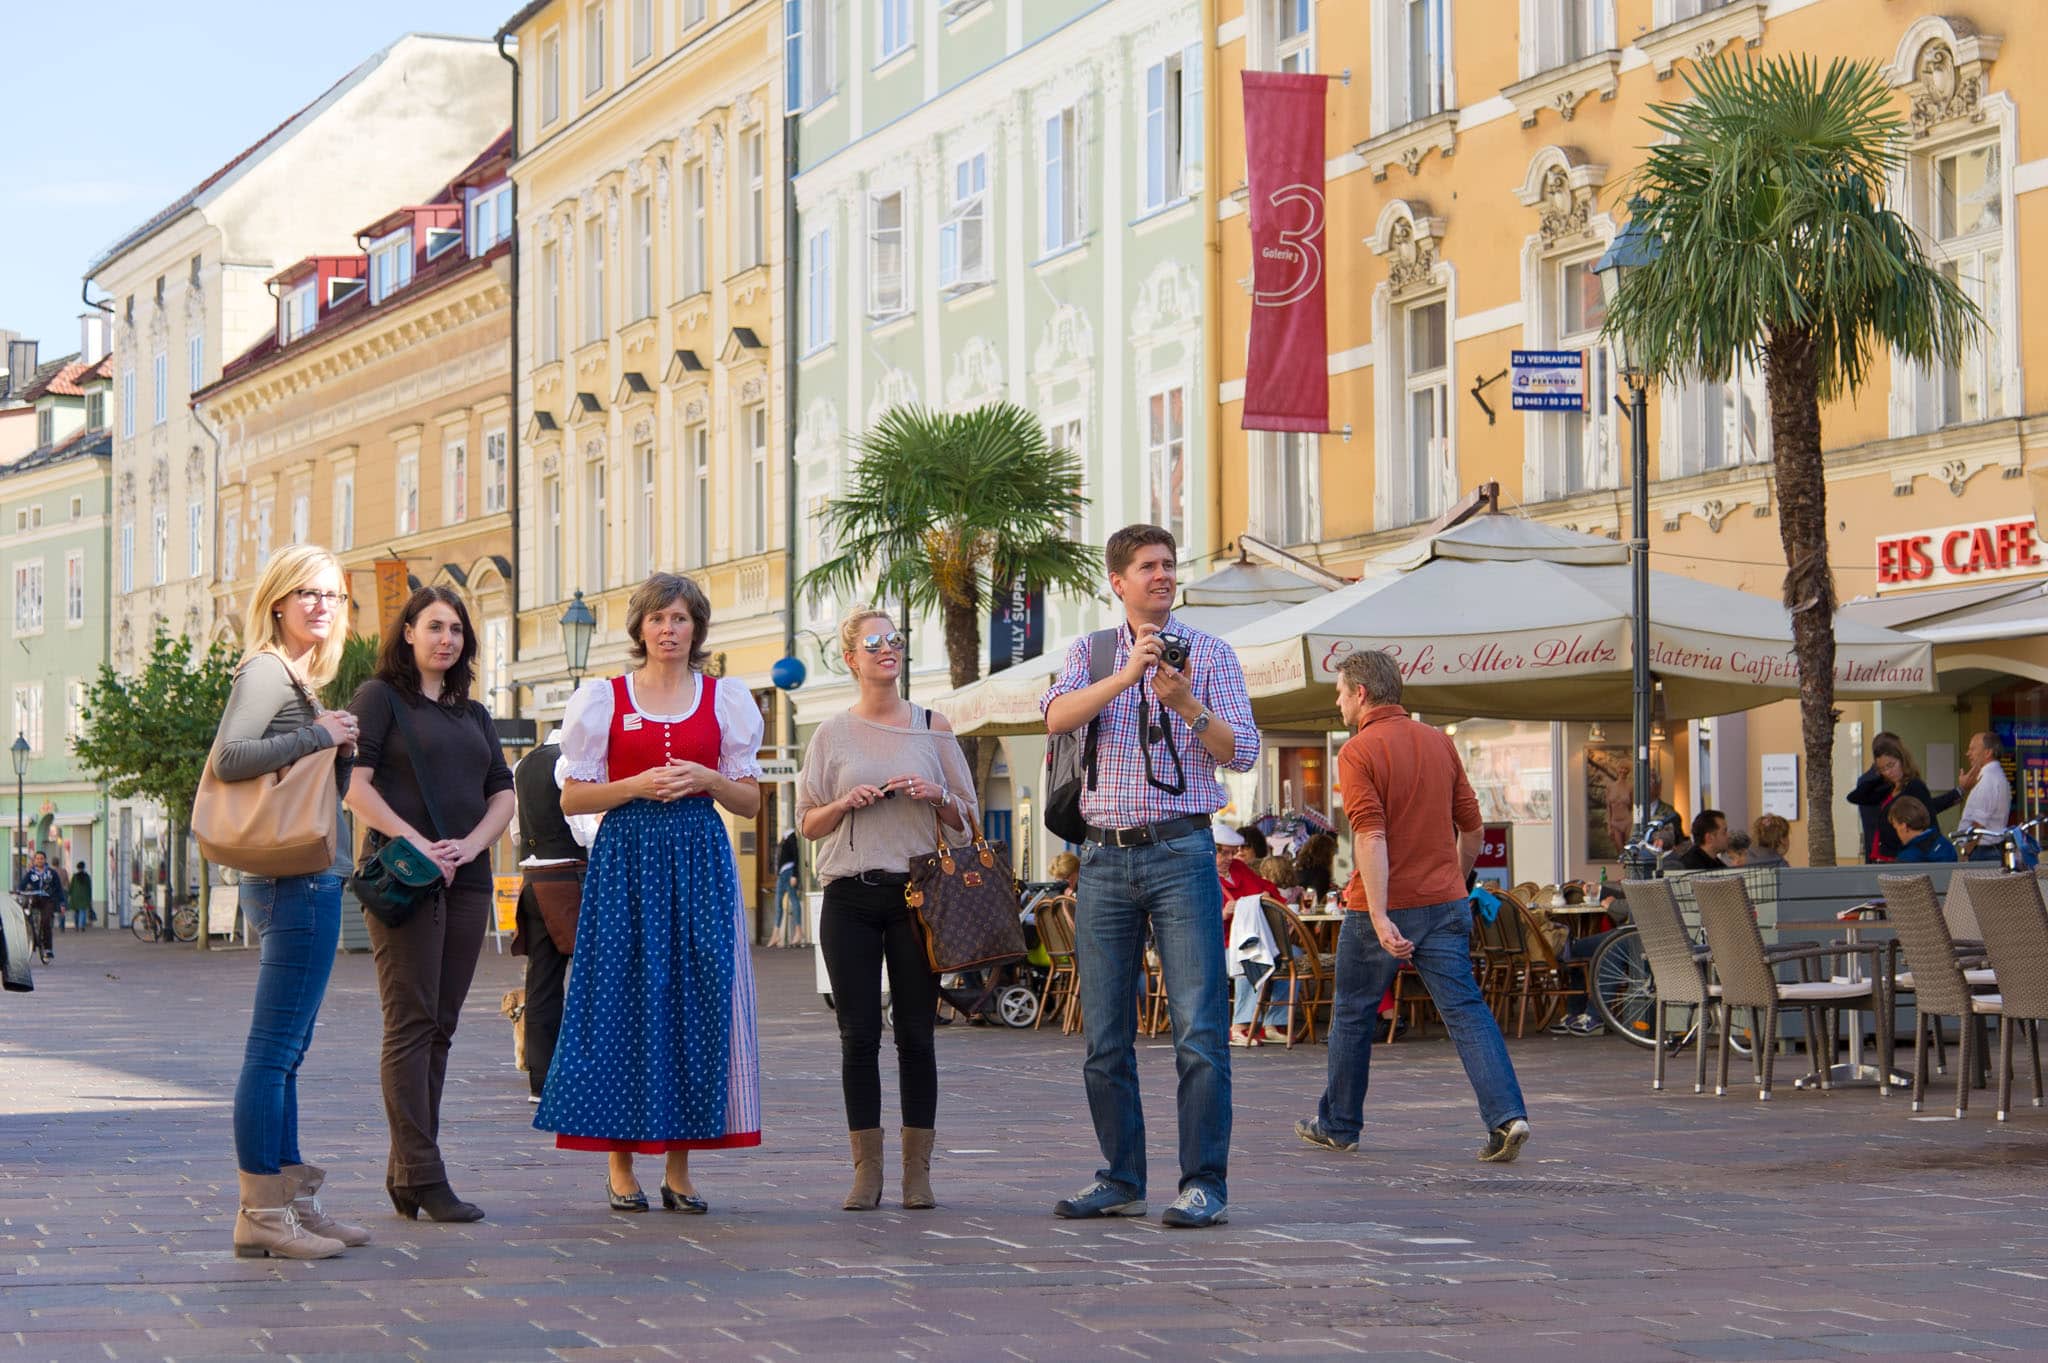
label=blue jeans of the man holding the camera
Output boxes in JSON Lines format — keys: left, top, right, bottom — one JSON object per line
{"left": 1075, "top": 829, "right": 1231, "bottom": 1201}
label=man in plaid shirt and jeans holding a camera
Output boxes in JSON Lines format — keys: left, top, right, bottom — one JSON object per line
{"left": 1038, "top": 526, "right": 1260, "bottom": 1228}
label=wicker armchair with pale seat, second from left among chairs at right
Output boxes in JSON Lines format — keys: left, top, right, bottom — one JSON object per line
{"left": 1692, "top": 874, "right": 1892, "bottom": 1103}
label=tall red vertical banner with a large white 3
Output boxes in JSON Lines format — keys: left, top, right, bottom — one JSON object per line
{"left": 1243, "top": 72, "right": 1329, "bottom": 432}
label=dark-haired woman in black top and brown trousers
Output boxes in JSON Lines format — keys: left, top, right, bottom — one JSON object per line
{"left": 348, "top": 587, "right": 514, "bottom": 1222}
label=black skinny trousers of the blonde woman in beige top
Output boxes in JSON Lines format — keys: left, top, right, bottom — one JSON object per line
{"left": 817, "top": 876, "right": 938, "bottom": 1132}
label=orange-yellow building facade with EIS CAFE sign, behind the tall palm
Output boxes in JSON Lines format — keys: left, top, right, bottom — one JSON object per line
{"left": 1212, "top": 0, "right": 2048, "bottom": 878}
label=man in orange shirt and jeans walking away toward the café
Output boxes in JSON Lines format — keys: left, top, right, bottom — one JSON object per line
{"left": 1294, "top": 651, "right": 1530, "bottom": 1164}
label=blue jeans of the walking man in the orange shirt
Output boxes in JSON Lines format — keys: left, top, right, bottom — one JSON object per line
{"left": 1317, "top": 898, "right": 1528, "bottom": 1140}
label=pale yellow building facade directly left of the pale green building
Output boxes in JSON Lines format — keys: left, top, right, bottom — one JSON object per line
{"left": 504, "top": 0, "right": 788, "bottom": 912}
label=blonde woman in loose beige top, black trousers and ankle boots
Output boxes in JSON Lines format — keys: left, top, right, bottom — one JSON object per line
{"left": 797, "top": 606, "right": 975, "bottom": 1212}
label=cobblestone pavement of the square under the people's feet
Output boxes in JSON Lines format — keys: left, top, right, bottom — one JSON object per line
{"left": 0, "top": 933, "right": 2048, "bottom": 1363}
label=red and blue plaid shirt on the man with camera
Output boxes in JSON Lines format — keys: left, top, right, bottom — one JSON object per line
{"left": 1038, "top": 616, "right": 1260, "bottom": 829}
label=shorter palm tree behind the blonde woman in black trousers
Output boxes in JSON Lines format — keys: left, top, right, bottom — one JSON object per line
{"left": 799, "top": 403, "right": 1100, "bottom": 784}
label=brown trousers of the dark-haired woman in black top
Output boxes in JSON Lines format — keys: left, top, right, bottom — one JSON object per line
{"left": 369, "top": 884, "right": 492, "bottom": 1187}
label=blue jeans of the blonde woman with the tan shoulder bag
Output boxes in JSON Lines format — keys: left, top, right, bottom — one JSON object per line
{"left": 236, "top": 872, "right": 342, "bottom": 1175}
